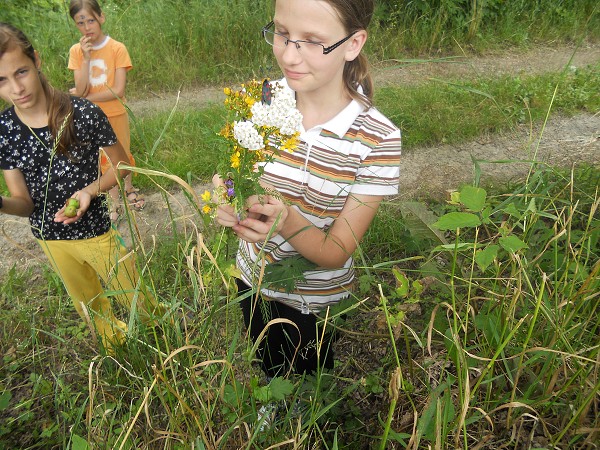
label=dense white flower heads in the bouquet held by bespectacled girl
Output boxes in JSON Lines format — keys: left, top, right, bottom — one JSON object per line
{"left": 251, "top": 85, "right": 302, "bottom": 135}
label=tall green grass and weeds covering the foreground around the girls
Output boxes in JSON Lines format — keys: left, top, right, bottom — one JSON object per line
{"left": 0, "top": 154, "right": 600, "bottom": 449}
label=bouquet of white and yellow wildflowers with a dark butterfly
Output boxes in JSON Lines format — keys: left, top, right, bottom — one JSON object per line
{"left": 202, "top": 80, "right": 302, "bottom": 218}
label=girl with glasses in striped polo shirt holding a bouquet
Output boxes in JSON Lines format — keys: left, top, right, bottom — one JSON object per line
{"left": 213, "top": 0, "right": 400, "bottom": 377}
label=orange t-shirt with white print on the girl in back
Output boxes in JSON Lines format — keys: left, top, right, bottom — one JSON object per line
{"left": 69, "top": 36, "right": 133, "bottom": 117}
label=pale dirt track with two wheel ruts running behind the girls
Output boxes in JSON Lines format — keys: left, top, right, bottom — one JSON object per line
{"left": 0, "top": 46, "right": 600, "bottom": 276}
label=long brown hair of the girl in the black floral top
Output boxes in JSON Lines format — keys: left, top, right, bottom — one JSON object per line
{"left": 0, "top": 22, "right": 76, "bottom": 156}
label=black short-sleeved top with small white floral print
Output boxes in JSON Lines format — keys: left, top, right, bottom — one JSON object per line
{"left": 0, "top": 97, "right": 117, "bottom": 240}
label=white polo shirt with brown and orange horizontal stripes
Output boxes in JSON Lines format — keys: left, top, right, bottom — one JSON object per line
{"left": 237, "top": 79, "right": 401, "bottom": 313}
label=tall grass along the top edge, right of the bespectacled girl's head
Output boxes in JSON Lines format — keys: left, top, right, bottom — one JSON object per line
{"left": 375, "top": 0, "right": 600, "bottom": 56}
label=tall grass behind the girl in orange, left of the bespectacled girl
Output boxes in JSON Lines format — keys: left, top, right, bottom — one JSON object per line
{"left": 3, "top": 0, "right": 272, "bottom": 96}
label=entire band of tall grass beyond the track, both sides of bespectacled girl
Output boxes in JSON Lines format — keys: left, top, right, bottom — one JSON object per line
{"left": 0, "top": 0, "right": 600, "bottom": 96}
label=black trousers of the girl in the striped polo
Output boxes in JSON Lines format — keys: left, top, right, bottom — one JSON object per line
{"left": 237, "top": 279, "right": 335, "bottom": 377}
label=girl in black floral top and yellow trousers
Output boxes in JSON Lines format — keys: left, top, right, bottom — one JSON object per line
{"left": 0, "top": 22, "right": 162, "bottom": 352}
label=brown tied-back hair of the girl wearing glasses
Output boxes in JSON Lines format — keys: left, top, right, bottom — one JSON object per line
{"left": 325, "top": 0, "right": 375, "bottom": 107}
